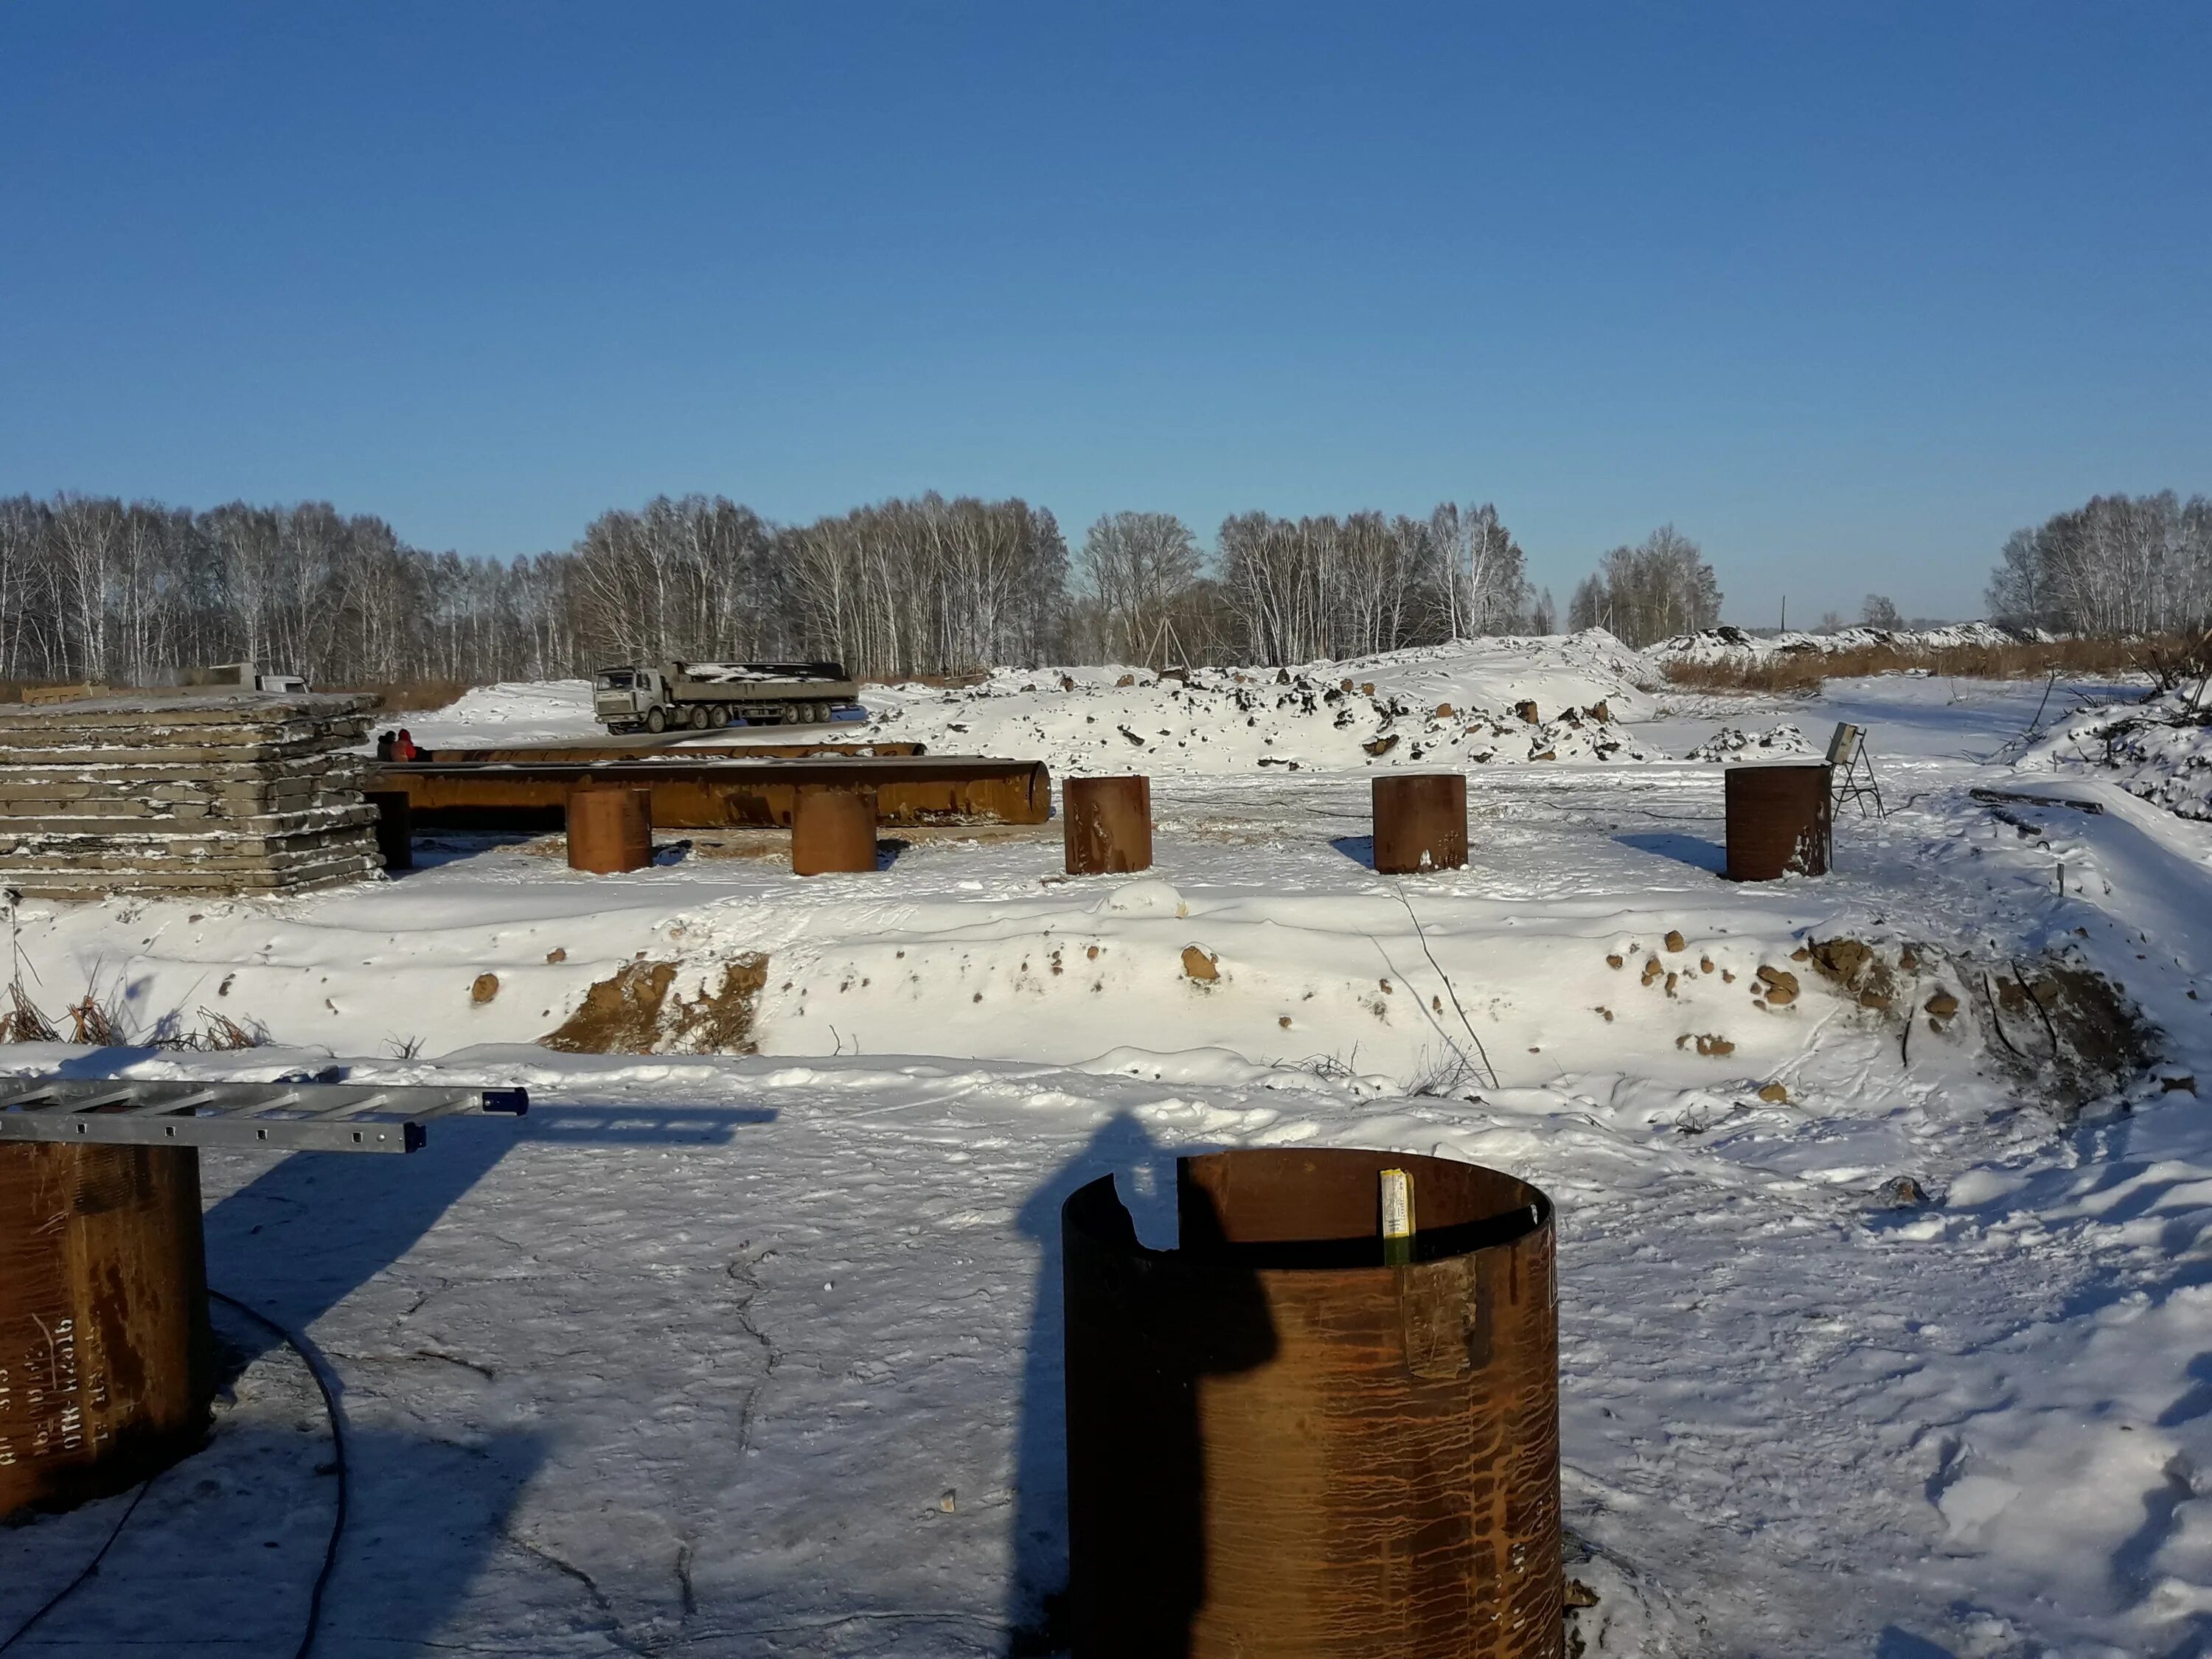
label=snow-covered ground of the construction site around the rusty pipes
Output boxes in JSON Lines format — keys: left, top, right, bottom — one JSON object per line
{"left": 0, "top": 637, "right": 2212, "bottom": 1659}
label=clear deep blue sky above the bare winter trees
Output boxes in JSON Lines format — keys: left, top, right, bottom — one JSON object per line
{"left": 0, "top": 0, "right": 2212, "bottom": 624}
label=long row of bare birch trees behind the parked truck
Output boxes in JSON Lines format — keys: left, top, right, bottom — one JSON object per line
{"left": 0, "top": 493, "right": 1555, "bottom": 686}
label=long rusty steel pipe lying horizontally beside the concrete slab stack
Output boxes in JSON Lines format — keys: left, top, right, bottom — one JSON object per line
{"left": 367, "top": 754, "right": 1053, "bottom": 830}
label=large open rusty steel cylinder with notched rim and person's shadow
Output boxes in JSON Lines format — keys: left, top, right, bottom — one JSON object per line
{"left": 1062, "top": 1150, "right": 1564, "bottom": 1659}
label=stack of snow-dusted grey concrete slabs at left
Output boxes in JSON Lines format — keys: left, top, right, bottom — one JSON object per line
{"left": 0, "top": 692, "right": 383, "bottom": 898}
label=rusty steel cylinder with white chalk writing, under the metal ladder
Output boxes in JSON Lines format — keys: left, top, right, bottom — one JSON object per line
{"left": 0, "top": 1141, "right": 215, "bottom": 1515}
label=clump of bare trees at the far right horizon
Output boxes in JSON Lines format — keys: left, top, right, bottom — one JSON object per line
{"left": 1989, "top": 489, "right": 2212, "bottom": 639}
